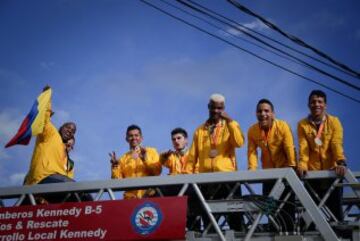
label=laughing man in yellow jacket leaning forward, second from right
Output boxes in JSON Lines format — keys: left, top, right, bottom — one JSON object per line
{"left": 247, "top": 99, "right": 296, "bottom": 231}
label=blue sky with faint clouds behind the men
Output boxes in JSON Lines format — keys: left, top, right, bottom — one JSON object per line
{"left": 0, "top": 0, "right": 360, "bottom": 186}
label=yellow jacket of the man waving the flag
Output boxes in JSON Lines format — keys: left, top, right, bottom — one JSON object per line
{"left": 25, "top": 104, "right": 69, "bottom": 185}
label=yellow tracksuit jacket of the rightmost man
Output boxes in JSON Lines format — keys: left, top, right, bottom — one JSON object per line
{"left": 297, "top": 115, "right": 346, "bottom": 170}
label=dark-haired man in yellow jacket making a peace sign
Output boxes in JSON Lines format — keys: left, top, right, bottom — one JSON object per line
{"left": 109, "top": 125, "right": 161, "bottom": 199}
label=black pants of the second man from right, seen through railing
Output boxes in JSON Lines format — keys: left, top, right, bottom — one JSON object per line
{"left": 263, "top": 181, "right": 295, "bottom": 232}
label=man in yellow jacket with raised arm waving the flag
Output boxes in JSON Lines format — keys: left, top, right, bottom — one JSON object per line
{"left": 24, "top": 86, "right": 76, "bottom": 185}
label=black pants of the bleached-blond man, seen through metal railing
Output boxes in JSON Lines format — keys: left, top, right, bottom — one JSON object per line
{"left": 200, "top": 183, "right": 244, "bottom": 231}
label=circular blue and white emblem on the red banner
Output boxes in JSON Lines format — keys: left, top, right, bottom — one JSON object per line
{"left": 131, "top": 202, "right": 162, "bottom": 235}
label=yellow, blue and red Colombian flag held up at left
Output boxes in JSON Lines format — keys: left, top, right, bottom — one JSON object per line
{"left": 5, "top": 88, "right": 51, "bottom": 148}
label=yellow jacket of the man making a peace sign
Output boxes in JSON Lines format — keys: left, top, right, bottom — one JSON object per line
{"left": 111, "top": 147, "right": 161, "bottom": 199}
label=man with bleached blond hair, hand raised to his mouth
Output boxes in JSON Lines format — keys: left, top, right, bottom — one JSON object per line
{"left": 186, "top": 94, "right": 244, "bottom": 230}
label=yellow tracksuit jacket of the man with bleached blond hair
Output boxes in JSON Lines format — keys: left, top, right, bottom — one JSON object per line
{"left": 186, "top": 120, "right": 244, "bottom": 174}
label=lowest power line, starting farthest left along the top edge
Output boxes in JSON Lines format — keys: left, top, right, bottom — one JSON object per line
{"left": 140, "top": 0, "right": 360, "bottom": 104}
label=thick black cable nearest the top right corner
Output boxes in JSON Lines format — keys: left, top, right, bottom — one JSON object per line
{"left": 227, "top": 0, "right": 360, "bottom": 77}
